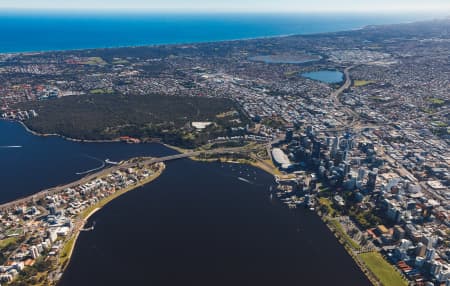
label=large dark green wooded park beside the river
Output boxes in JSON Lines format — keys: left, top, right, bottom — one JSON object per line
{"left": 18, "top": 94, "right": 245, "bottom": 147}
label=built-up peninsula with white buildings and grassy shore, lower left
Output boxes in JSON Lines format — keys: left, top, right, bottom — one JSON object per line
{"left": 0, "top": 155, "right": 165, "bottom": 285}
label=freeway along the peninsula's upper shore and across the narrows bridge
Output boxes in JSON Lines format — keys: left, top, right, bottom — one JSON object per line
{"left": 0, "top": 147, "right": 251, "bottom": 212}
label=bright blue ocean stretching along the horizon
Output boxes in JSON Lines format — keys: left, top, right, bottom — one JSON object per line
{"left": 0, "top": 11, "right": 440, "bottom": 53}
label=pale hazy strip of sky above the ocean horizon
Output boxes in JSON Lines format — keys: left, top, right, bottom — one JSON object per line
{"left": 0, "top": 0, "right": 450, "bottom": 13}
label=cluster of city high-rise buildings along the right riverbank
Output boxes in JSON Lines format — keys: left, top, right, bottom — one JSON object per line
{"left": 274, "top": 125, "right": 450, "bottom": 285}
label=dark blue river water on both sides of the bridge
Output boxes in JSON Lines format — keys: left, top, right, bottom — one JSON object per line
{"left": 0, "top": 121, "right": 370, "bottom": 286}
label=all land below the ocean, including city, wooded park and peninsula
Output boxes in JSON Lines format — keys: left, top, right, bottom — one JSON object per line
{"left": 0, "top": 19, "right": 450, "bottom": 286}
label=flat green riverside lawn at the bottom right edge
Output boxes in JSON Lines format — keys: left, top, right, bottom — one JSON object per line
{"left": 358, "top": 252, "right": 408, "bottom": 286}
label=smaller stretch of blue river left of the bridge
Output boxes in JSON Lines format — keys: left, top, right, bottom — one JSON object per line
{"left": 0, "top": 120, "right": 175, "bottom": 203}
